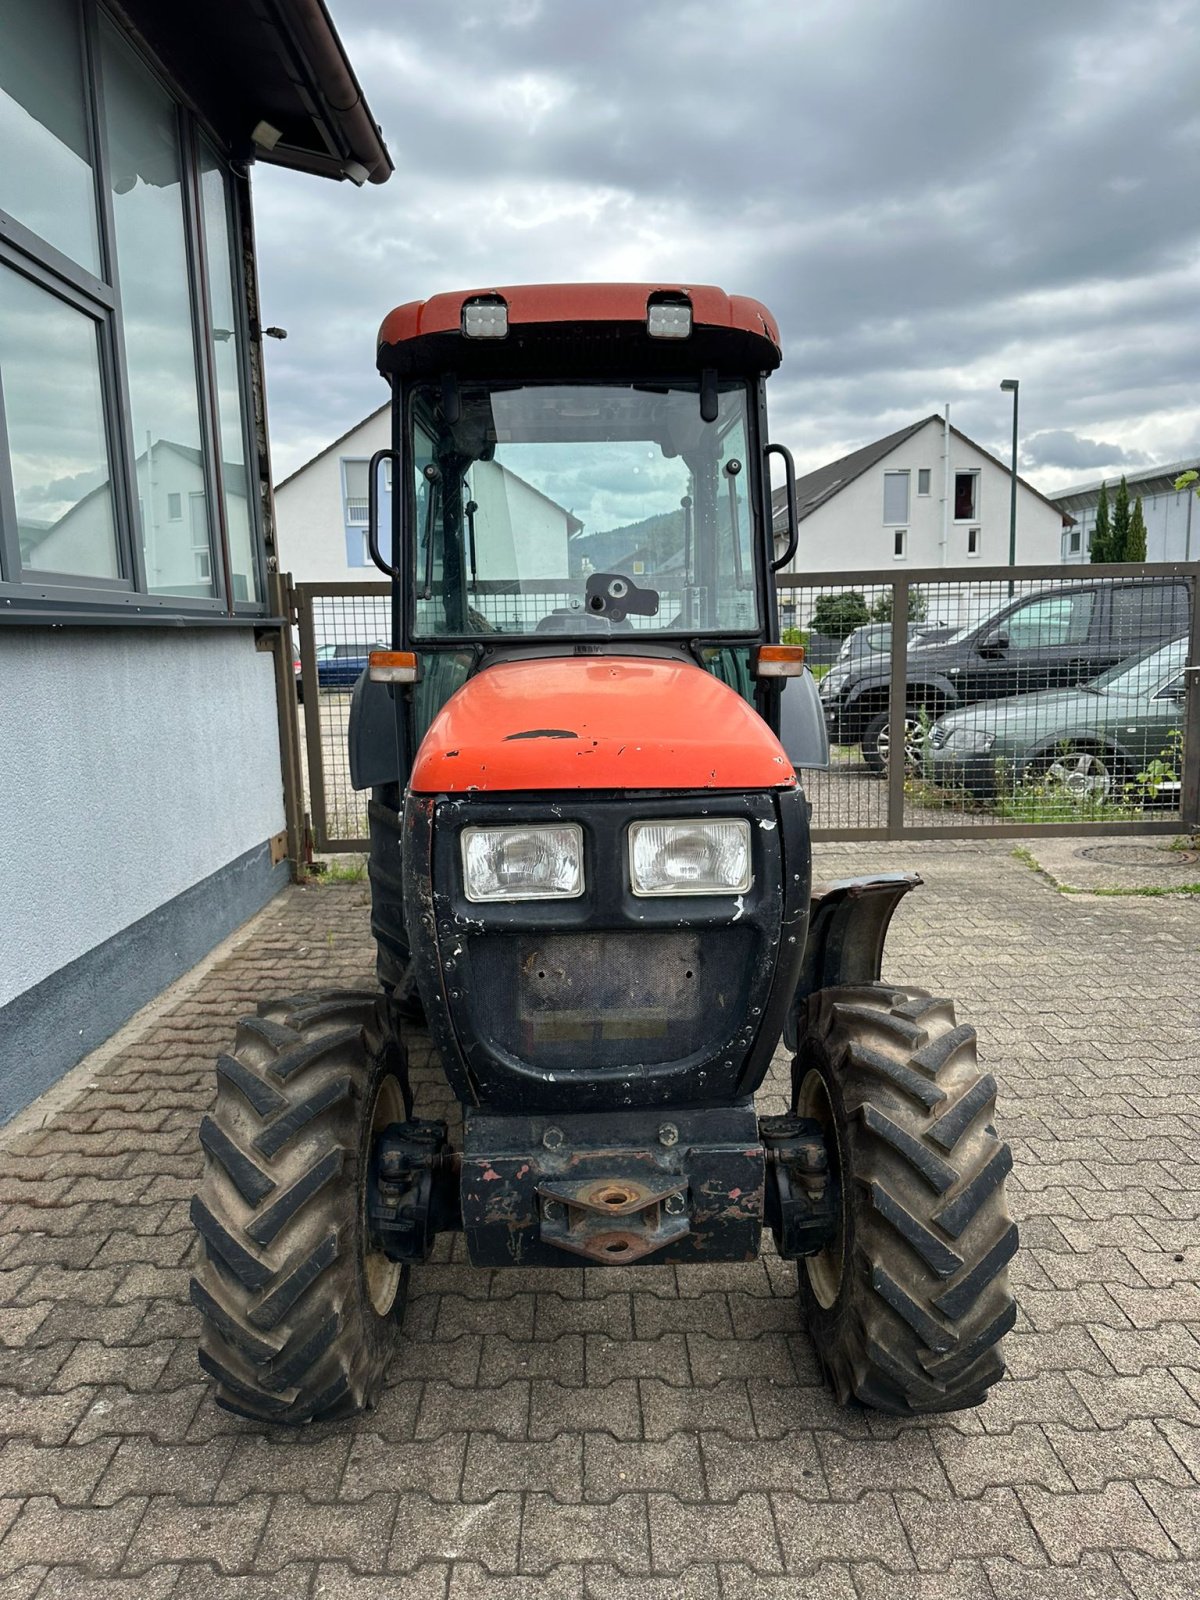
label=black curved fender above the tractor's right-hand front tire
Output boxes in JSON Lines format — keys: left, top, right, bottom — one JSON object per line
{"left": 784, "top": 872, "right": 922, "bottom": 1050}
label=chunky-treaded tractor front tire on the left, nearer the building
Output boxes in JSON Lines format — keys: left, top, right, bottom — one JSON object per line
{"left": 192, "top": 990, "right": 411, "bottom": 1422}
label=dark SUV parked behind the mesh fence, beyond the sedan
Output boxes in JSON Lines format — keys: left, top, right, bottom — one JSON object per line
{"left": 821, "top": 578, "right": 1189, "bottom": 773}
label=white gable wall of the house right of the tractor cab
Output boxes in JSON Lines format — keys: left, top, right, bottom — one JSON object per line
{"left": 789, "top": 422, "right": 1062, "bottom": 574}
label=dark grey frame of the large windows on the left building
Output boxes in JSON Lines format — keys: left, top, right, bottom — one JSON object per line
{"left": 0, "top": 0, "right": 269, "bottom": 624}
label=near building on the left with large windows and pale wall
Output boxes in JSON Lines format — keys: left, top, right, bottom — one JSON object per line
{"left": 0, "top": 0, "right": 392, "bottom": 1122}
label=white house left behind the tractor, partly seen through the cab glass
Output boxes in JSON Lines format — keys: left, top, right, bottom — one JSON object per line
{"left": 275, "top": 405, "right": 582, "bottom": 584}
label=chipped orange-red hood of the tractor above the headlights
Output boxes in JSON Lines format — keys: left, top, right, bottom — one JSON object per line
{"left": 411, "top": 656, "right": 795, "bottom": 794}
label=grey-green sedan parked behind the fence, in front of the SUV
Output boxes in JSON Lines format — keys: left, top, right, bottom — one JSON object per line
{"left": 922, "top": 635, "right": 1187, "bottom": 800}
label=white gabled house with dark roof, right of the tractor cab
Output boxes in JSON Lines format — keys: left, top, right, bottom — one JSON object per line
{"left": 773, "top": 413, "right": 1072, "bottom": 578}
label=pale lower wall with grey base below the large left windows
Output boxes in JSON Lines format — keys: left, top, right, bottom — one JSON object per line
{"left": 0, "top": 627, "right": 286, "bottom": 1122}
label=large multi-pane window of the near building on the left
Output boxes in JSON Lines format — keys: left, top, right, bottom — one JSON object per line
{"left": 0, "top": 0, "right": 262, "bottom": 619}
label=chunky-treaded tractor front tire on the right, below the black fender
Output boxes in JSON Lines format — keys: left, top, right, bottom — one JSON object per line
{"left": 792, "top": 984, "right": 1018, "bottom": 1416}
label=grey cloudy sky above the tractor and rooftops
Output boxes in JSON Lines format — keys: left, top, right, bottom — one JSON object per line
{"left": 254, "top": 0, "right": 1200, "bottom": 490}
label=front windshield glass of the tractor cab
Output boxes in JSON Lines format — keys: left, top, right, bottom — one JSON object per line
{"left": 408, "top": 382, "right": 758, "bottom": 638}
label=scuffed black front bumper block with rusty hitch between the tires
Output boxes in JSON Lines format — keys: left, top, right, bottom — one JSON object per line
{"left": 461, "top": 1102, "right": 765, "bottom": 1267}
